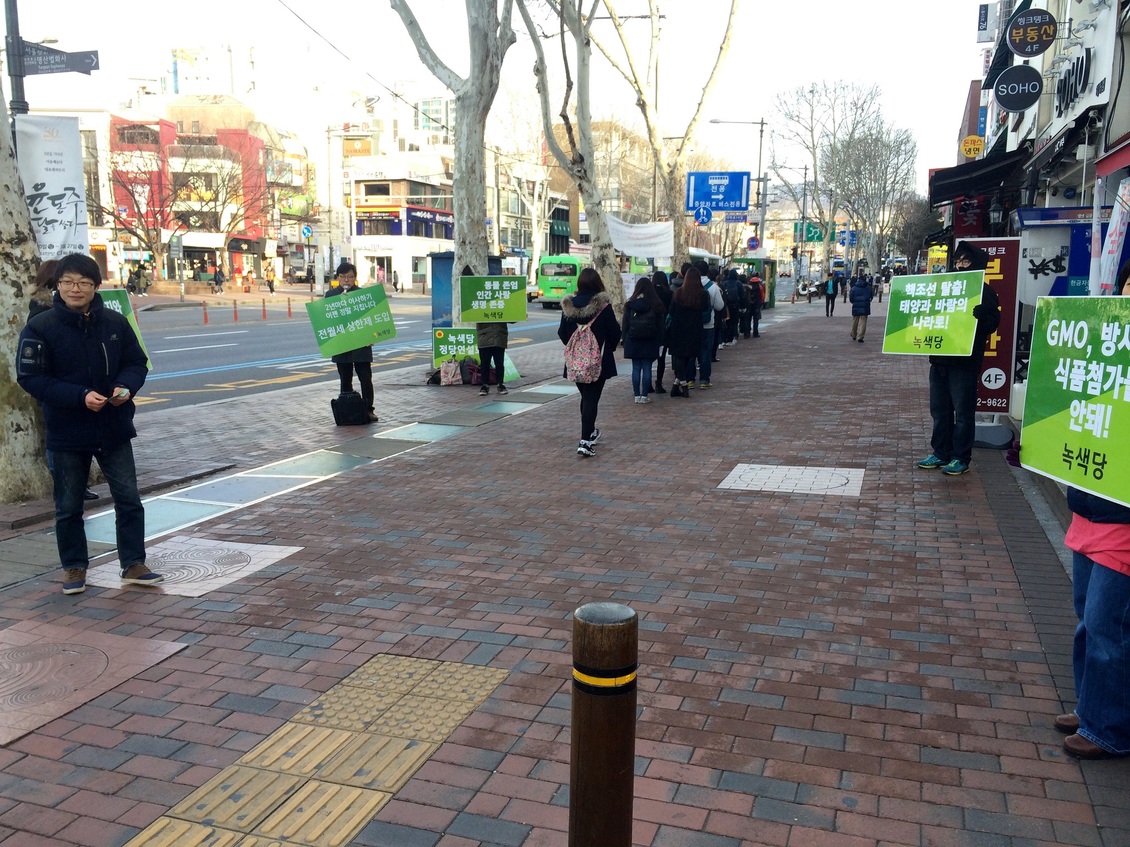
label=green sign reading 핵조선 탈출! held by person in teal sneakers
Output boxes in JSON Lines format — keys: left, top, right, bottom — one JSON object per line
{"left": 883, "top": 271, "right": 984, "bottom": 356}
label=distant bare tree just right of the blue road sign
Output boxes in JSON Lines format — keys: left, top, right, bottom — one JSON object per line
{"left": 770, "top": 81, "right": 880, "bottom": 275}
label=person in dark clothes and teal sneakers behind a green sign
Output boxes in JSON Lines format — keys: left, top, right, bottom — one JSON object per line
{"left": 918, "top": 242, "right": 1000, "bottom": 477}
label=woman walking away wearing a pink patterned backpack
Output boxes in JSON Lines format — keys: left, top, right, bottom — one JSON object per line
{"left": 557, "top": 268, "right": 620, "bottom": 457}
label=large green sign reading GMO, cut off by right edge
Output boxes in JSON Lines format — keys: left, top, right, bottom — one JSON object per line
{"left": 1020, "top": 297, "right": 1130, "bottom": 506}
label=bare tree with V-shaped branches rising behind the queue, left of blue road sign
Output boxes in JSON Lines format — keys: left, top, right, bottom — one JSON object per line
{"left": 583, "top": 0, "right": 741, "bottom": 268}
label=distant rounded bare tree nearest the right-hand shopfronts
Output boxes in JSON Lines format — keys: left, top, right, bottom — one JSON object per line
{"left": 825, "top": 116, "right": 918, "bottom": 268}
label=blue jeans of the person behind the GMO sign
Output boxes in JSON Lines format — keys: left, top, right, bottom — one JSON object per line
{"left": 1071, "top": 553, "right": 1130, "bottom": 753}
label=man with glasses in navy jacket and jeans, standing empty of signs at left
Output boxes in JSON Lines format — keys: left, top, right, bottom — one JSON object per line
{"left": 16, "top": 253, "right": 163, "bottom": 594}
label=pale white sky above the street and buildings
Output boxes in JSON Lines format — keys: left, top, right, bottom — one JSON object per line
{"left": 2, "top": 0, "right": 986, "bottom": 193}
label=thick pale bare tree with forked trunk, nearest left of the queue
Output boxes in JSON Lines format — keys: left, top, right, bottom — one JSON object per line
{"left": 389, "top": 0, "right": 515, "bottom": 302}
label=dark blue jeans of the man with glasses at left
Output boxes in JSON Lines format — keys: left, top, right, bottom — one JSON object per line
{"left": 52, "top": 440, "right": 145, "bottom": 570}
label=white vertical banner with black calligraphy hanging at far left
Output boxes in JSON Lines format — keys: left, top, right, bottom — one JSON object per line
{"left": 16, "top": 115, "right": 90, "bottom": 261}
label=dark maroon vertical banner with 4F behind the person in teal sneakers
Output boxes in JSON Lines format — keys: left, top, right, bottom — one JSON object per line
{"left": 966, "top": 238, "right": 1020, "bottom": 414}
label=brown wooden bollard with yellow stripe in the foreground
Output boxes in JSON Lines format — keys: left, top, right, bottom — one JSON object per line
{"left": 568, "top": 603, "right": 640, "bottom": 847}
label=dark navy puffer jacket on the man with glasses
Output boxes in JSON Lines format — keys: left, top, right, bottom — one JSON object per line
{"left": 16, "top": 294, "right": 149, "bottom": 452}
